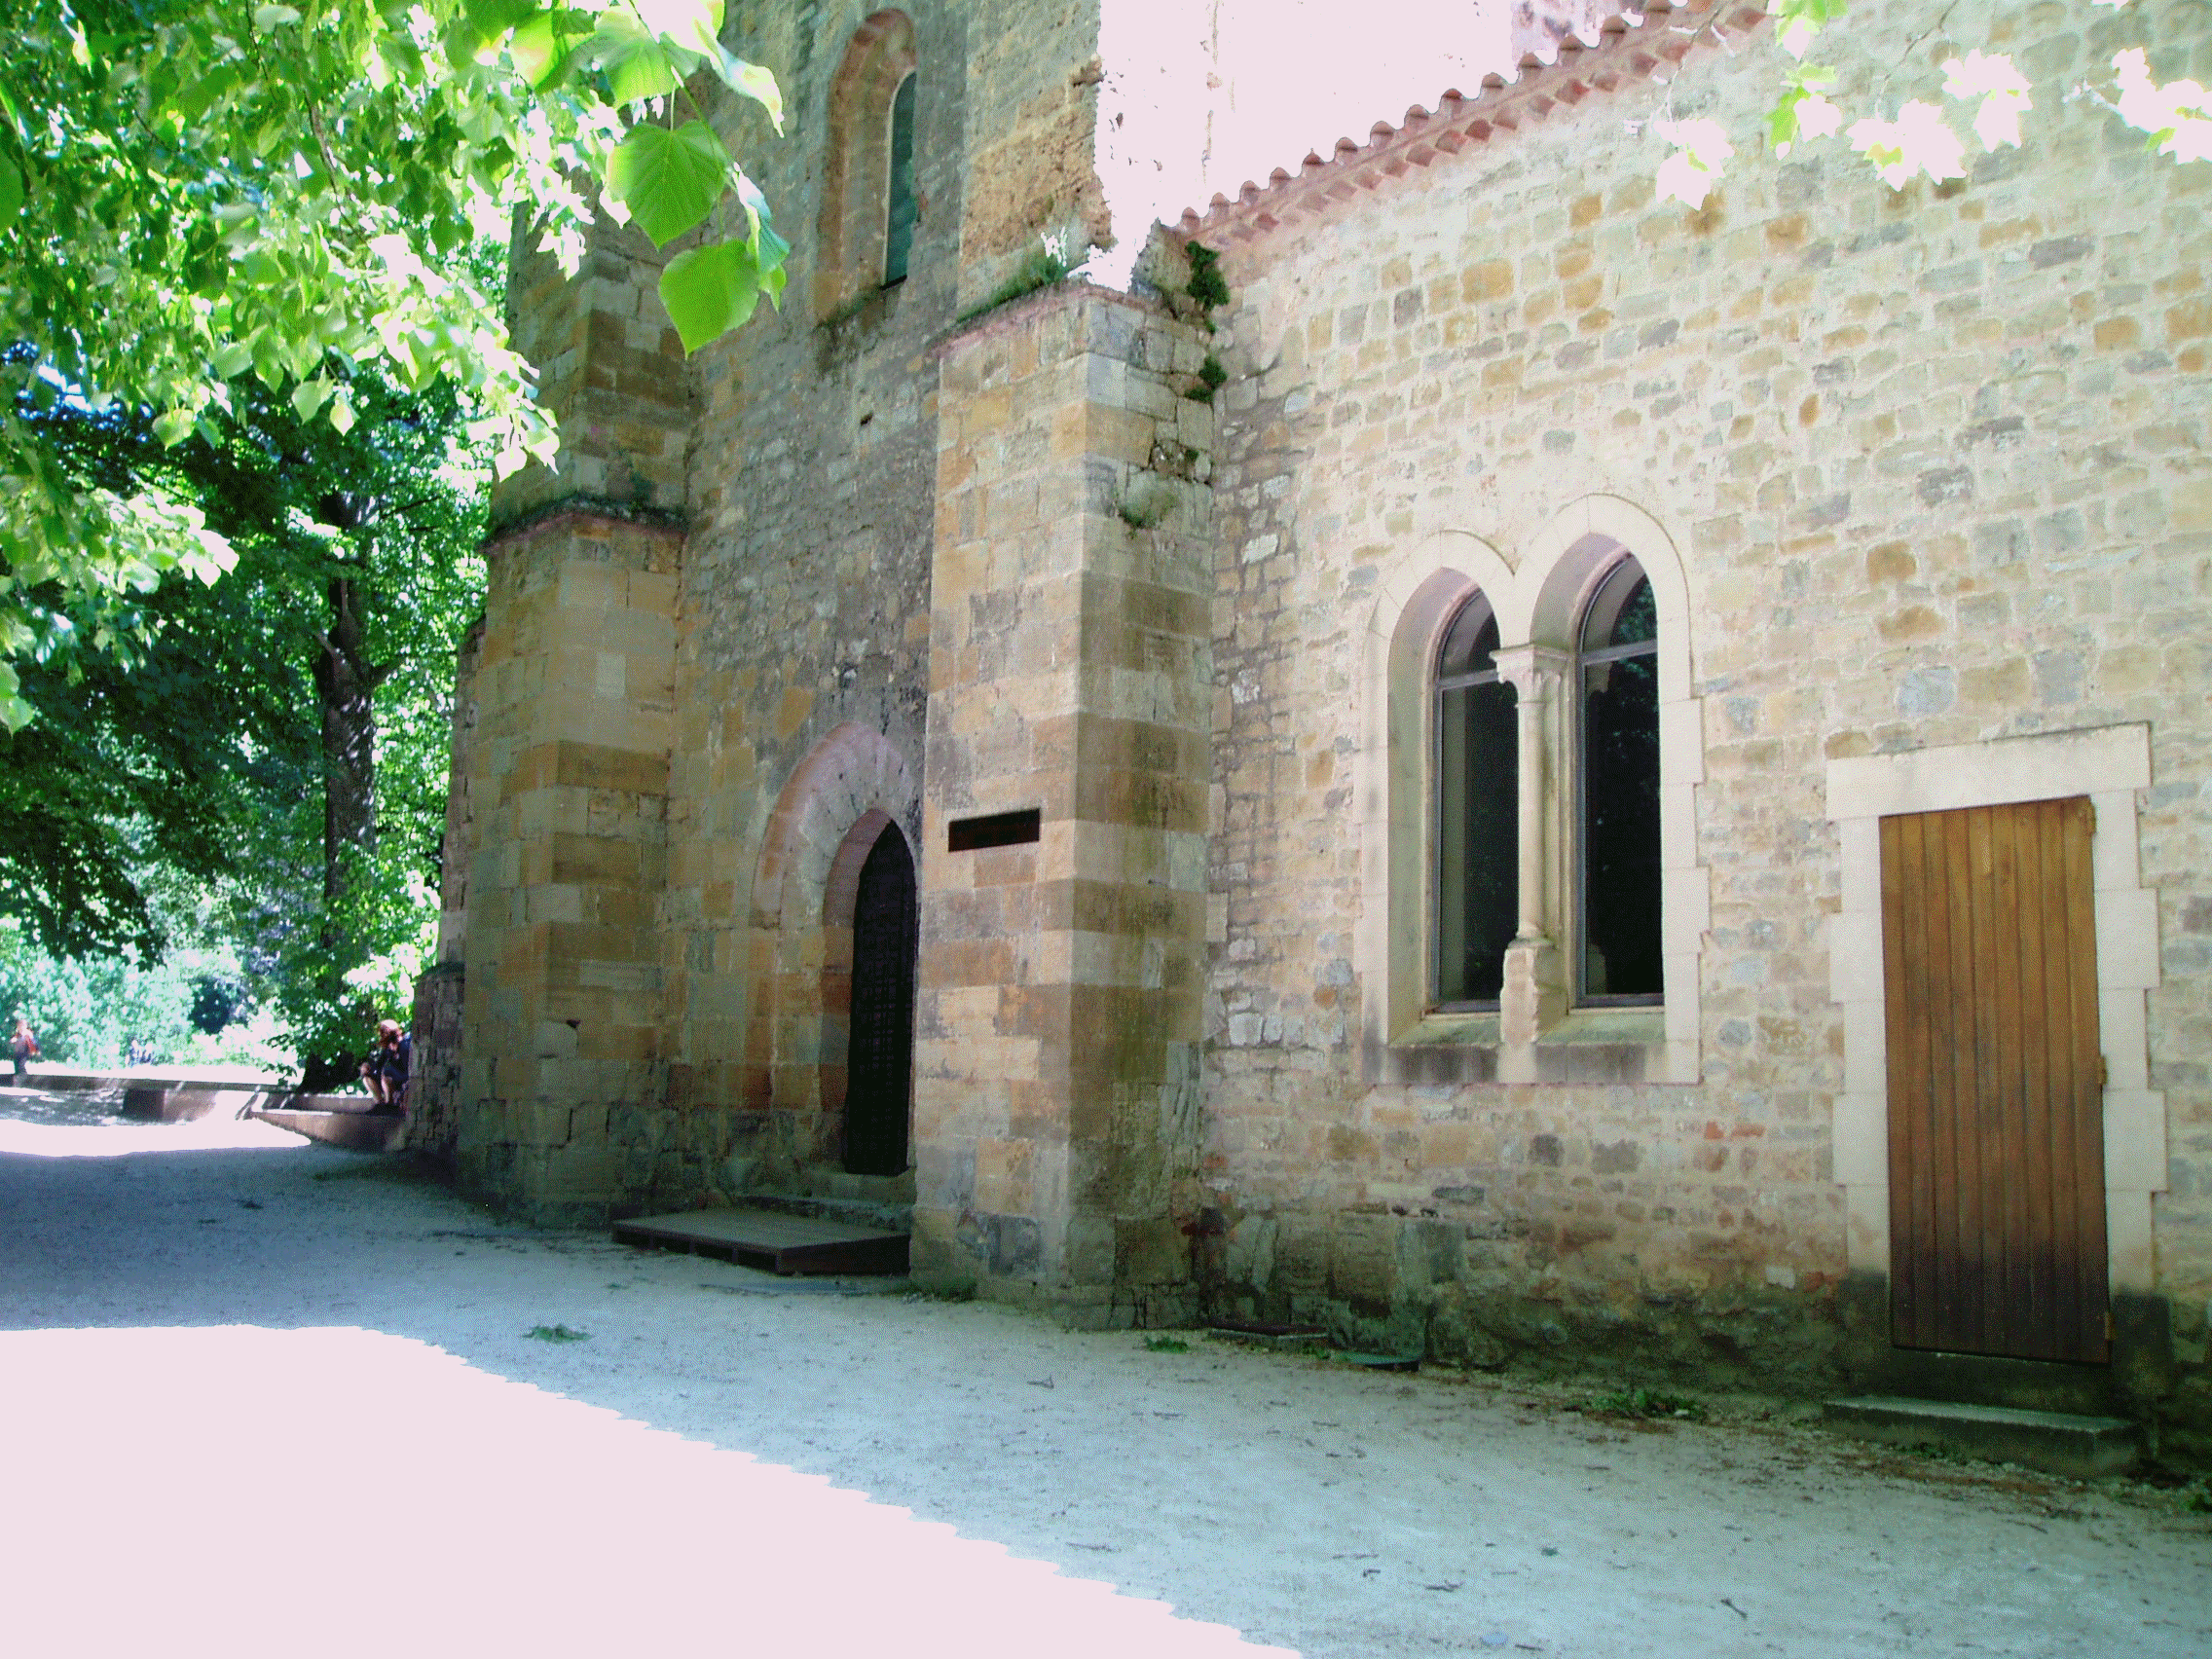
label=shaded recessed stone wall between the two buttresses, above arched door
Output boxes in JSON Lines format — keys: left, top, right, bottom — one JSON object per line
{"left": 652, "top": 5, "right": 969, "bottom": 1195}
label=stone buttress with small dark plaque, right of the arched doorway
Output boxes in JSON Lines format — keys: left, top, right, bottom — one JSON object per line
{"left": 913, "top": 287, "right": 1212, "bottom": 1323}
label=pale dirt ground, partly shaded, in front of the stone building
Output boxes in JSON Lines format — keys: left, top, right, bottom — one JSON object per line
{"left": 0, "top": 1090, "right": 2212, "bottom": 1659}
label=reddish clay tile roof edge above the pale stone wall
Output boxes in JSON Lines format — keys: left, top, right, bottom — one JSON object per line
{"left": 1174, "top": 0, "right": 1767, "bottom": 243}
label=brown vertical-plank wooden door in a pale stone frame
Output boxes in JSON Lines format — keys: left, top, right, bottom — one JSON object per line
{"left": 1882, "top": 796, "right": 2108, "bottom": 1363}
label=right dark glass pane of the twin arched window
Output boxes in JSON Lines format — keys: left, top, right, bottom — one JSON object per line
{"left": 1579, "top": 560, "right": 1661, "bottom": 1002}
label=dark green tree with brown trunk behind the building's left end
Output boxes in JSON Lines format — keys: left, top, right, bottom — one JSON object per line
{"left": 0, "top": 374, "right": 489, "bottom": 1087}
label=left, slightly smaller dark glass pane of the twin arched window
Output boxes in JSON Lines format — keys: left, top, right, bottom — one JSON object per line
{"left": 1436, "top": 593, "right": 1520, "bottom": 1004}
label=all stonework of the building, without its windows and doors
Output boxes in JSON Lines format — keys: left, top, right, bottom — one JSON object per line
{"left": 429, "top": 0, "right": 2212, "bottom": 1449}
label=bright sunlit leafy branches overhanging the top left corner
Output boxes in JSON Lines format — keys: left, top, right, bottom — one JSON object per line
{"left": 0, "top": 0, "right": 786, "bottom": 708}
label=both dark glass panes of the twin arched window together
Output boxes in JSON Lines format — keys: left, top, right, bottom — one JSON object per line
{"left": 1433, "top": 555, "right": 1664, "bottom": 1009}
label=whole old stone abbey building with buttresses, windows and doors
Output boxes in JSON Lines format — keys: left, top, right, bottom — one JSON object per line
{"left": 414, "top": 0, "right": 2212, "bottom": 1454}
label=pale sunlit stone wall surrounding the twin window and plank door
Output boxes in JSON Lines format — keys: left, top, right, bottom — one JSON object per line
{"left": 1205, "top": 5, "right": 2212, "bottom": 1420}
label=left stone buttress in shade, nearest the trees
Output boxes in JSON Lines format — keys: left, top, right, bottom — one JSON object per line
{"left": 456, "top": 509, "right": 682, "bottom": 1217}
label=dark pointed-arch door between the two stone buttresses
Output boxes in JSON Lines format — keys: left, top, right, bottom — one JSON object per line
{"left": 845, "top": 823, "right": 920, "bottom": 1174}
